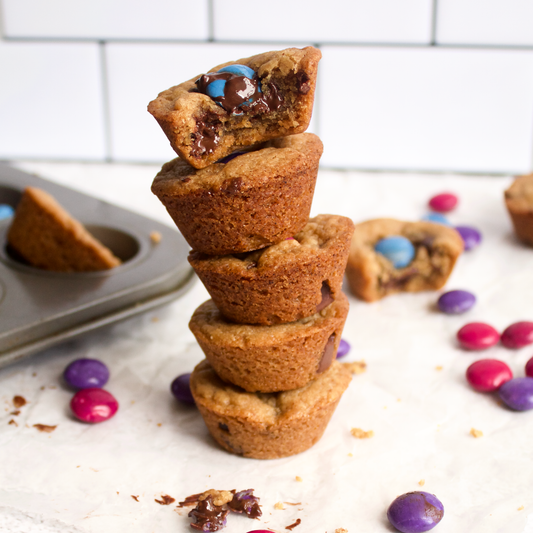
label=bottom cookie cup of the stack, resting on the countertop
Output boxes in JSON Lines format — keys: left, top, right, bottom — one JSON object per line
{"left": 191, "top": 360, "right": 351, "bottom": 459}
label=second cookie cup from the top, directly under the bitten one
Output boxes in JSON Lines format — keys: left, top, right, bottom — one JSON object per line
{"left": 152, "top": 133, "right": 322, "bottom": 255}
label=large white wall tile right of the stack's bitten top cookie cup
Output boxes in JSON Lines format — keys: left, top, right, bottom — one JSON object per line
{"left": 319, "top": 46, "right": 533, "bottom": 172}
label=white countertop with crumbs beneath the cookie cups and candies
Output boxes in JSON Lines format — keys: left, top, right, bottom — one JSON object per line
{"left": 0, "top": 163, "right": 533, "bottom": 533}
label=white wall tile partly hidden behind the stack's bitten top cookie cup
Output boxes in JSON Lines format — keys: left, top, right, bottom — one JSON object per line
{"left": 106, "top": 43, "right": 315, "bottom": 162}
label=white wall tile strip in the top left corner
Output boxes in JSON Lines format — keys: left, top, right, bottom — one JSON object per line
{"left": 3, "top": 0, "right": 209, "bottom": 40}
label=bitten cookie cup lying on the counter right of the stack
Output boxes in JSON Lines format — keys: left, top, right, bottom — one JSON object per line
{"left": 346, "top": 218, "right": 463, "bottom": 302}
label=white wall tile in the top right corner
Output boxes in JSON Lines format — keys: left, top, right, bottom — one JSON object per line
{"left": 437, "top": 0, "right": 533, "bottom": 46}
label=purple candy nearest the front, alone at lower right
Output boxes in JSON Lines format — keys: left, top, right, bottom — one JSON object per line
{"left": 387, "top": 491, "right": 444, "bottom": 533}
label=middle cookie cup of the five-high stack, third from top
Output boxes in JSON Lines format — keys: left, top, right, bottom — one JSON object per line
{"left": 189, "top": 215, "right": 354, "bottom": 325}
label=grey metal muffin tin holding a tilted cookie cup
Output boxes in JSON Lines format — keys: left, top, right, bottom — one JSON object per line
{"left": 0, "top": 165, "right": 194, "bottom": 366}
